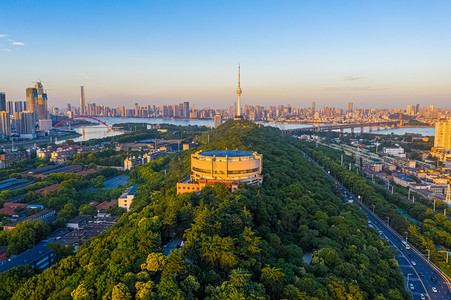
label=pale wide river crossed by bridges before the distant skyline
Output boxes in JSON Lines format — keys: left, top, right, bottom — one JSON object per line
{"left": 61, "top": 117, "right": 435, "bottom": 142}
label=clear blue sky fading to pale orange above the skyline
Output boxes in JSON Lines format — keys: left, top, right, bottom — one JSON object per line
{"left": 0, "top": 0, "right": 451, "bottom": 108}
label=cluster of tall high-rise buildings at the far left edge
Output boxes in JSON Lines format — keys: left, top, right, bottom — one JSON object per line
{"left": 0, "top": 82, "right": 52, "bottom": 138}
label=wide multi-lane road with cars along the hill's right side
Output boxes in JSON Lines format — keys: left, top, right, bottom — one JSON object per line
{"left": 304, "top": 153, "right": 451, "bottom": 300}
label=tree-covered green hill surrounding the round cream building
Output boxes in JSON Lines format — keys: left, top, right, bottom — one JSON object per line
{"left": 5, "top": 121, "right": 408, "bottom": 300}
